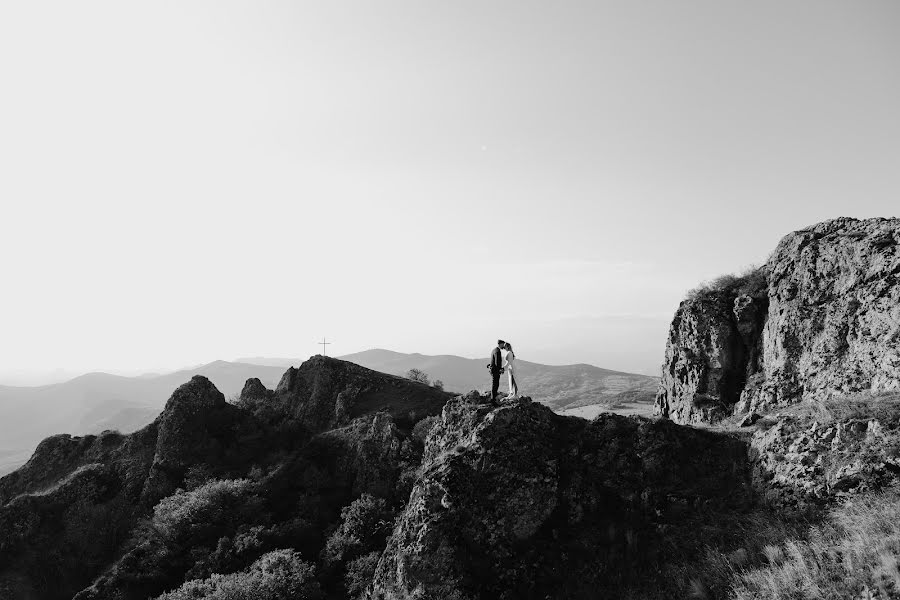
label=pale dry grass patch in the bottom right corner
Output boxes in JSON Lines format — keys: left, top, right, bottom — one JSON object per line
{"left": 733, "top": 490, "right": 900, "bottom": 600}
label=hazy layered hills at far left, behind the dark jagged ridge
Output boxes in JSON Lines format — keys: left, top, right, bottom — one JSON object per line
{"left": 0, "top": 361, "right": 284, "bottom": 474}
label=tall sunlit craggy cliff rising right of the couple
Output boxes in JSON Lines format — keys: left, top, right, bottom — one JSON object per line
{"left": 656, "top": 219, "right": 900, "bottom": 423}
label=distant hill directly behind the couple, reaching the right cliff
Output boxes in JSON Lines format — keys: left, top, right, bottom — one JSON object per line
{"left": 239, "top": 349, "right": 659, "bottom": 414}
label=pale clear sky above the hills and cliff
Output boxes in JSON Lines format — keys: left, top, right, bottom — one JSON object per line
{"left": 0, "top": 0, "right": 900, "bottom": 383}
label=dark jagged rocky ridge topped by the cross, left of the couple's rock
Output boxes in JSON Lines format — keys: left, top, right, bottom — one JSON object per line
{"left": 0, "top": 357, "right": 450, "bottom": 600}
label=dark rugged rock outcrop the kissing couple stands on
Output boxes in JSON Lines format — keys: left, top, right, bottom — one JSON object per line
{"left": 369, "top": 394, "right": 750, "bottom": 600}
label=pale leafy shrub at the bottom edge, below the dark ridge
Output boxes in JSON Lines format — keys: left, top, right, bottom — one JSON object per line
{"left": 157, "top": 550, "right": 324, "bottom": 600}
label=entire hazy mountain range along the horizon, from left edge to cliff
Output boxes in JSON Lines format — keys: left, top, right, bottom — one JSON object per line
{"left": 0, "top": 350, "right": 658, "bottom": 475}
